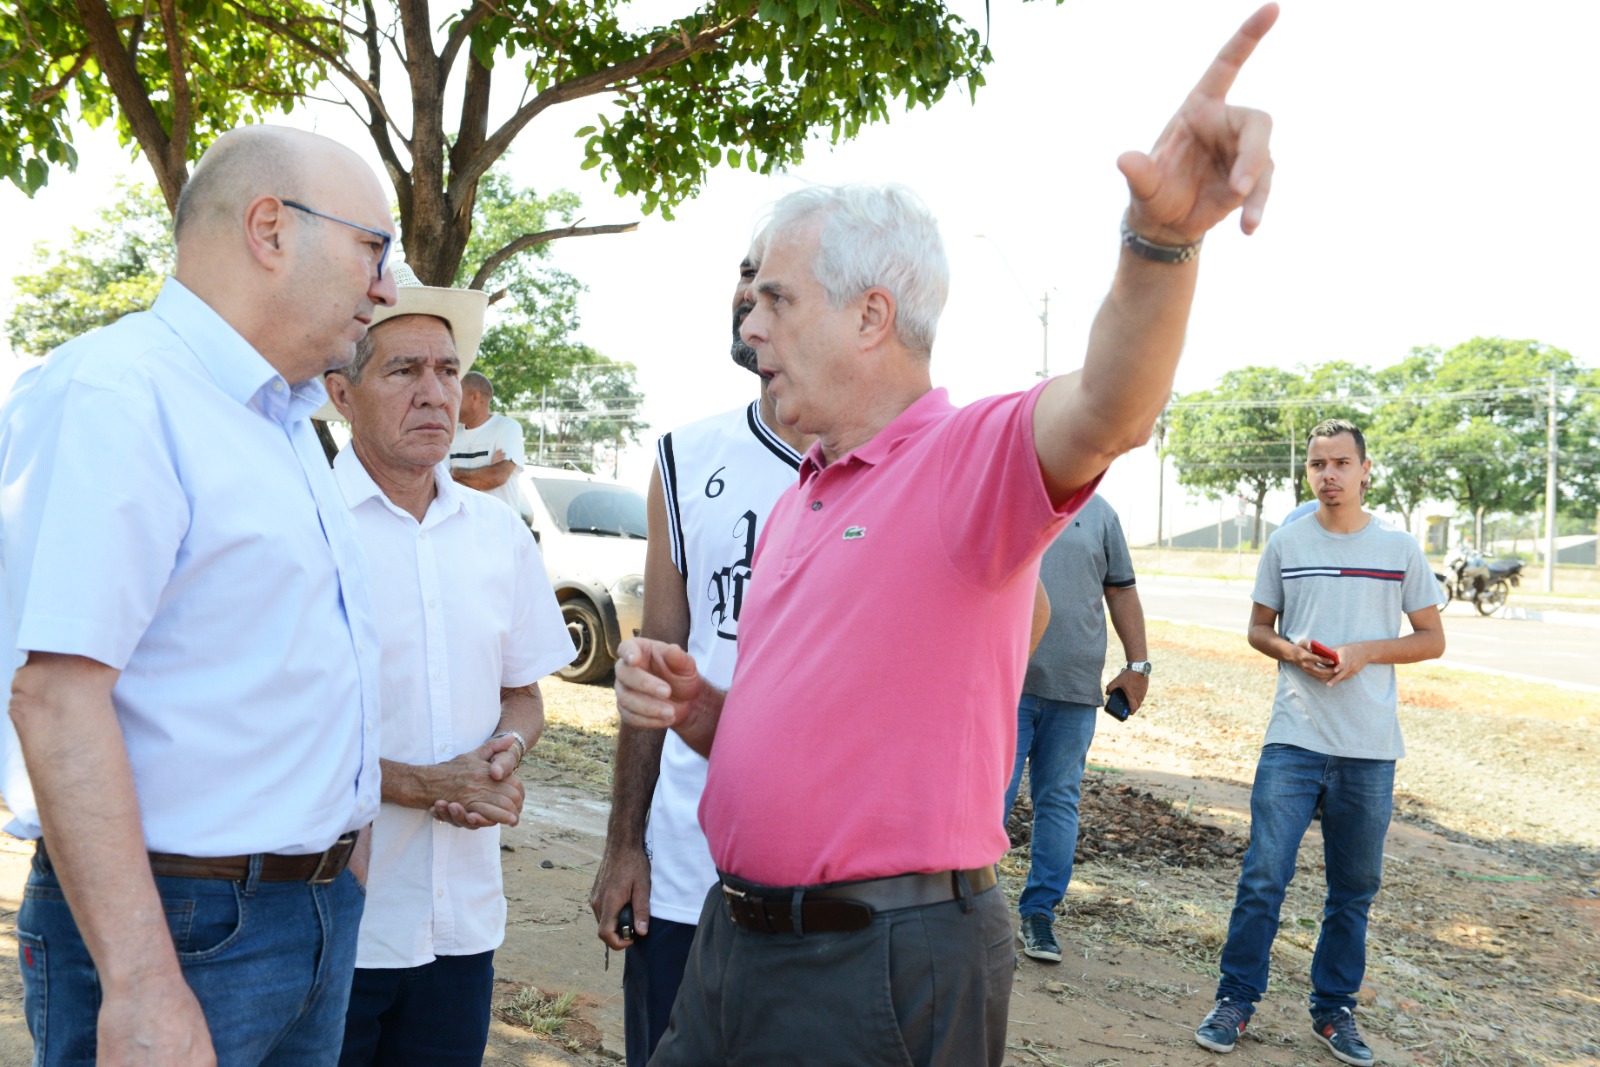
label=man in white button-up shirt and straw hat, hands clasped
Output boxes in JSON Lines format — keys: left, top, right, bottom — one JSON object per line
{"left": 328, "top": 272, "right": 573, "bottom": 1067}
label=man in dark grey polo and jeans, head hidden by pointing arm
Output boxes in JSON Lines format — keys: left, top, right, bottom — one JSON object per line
{"left": 1002, "top": 494, "right": 1150, "bottom": 963}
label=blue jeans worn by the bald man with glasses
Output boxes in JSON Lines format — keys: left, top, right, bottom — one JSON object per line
{"left": 16, "top": 856, "right": 366, "bottom": 1067}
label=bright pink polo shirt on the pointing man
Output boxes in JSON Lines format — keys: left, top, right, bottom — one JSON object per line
{"left": 701, "top": 386, "right": 1098, "bottom": 886}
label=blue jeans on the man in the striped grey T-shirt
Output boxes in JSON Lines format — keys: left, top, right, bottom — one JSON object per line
{"left": 1216, "top": 744, "right": 1395, "bottom": 1019}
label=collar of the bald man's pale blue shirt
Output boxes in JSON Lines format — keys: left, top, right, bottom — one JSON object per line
{"left": 150, "top": 278, "right": 328, "bottom": 422}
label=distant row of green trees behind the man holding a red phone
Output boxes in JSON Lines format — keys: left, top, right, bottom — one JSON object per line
{"left": 1160, "top": 338, "right": 1600, "bottom": 547}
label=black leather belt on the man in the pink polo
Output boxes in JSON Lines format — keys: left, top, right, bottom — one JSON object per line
{"left": 722, "top": 867, "right": 995, "bottom": 934}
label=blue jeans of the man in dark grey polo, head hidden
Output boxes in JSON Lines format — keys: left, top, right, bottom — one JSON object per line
{"left": 1000, "top": 693, "right": 1099, "bottom": 918}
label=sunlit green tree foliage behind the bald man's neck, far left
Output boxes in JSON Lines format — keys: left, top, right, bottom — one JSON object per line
{"left": 5, "top": 184, "right": 173, "bottom": 357}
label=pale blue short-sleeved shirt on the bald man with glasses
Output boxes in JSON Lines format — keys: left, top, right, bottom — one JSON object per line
{"left": 0, "top": 280, "right": 379, "bottom": 856}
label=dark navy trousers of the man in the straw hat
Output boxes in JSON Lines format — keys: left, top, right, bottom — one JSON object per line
{"left": 339, "top": 949, "right": 494, "bottom": 1067}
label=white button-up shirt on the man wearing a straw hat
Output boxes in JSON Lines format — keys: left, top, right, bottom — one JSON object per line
{"left": 334, "top": 448, "right": 573, "bottom": 968}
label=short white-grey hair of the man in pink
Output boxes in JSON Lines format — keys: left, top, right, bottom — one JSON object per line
{"left": 755, "top": 186, "right": 950, "bottom": 352}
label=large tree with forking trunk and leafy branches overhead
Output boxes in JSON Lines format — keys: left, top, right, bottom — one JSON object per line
{"left": 0, "top": 0, "right": 990, "bottom": 285}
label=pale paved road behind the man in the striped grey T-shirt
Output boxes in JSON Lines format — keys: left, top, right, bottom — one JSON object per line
{"left": 1139, "top": 574, "right": 1600, "bottom": 691}
